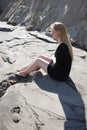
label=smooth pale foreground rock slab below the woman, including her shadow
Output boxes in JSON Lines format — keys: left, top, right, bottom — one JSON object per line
{"left": 0, "top": 72, "right": 86, "bottom": 130}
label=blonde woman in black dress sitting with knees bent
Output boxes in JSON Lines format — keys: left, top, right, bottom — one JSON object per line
{"left": 17, "top": 22, "right": 73, "bottom": 81}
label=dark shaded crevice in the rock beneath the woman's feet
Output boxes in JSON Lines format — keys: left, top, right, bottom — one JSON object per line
{"left": 0, "top": 73, "right": 33, "bottom": 98}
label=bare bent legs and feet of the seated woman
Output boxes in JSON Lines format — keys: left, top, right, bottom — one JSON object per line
{"left": 18, "top": 58, "right": 50, "bottom": 77}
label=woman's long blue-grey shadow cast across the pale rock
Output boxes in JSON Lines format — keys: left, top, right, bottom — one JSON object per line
{"left": 34, "top": 72, "right": 86, "bottom": 130}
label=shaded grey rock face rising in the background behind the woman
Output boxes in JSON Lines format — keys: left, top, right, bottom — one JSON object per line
{"left": 0, "top": 0, "right": 87, "bottom": 50}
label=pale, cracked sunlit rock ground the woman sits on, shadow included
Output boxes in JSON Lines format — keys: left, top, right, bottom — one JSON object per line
{"left": 0, "top": 22, "right": 87, "bottom": 130}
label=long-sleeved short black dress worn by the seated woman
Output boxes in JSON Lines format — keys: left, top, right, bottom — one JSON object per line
{"left": 47, "top": 43, "right": 72, "bottom": 81}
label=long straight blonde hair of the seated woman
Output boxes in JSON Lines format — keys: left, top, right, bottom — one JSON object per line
{"left": 51, "top": 22, "right": 73, "bottom": 60}
